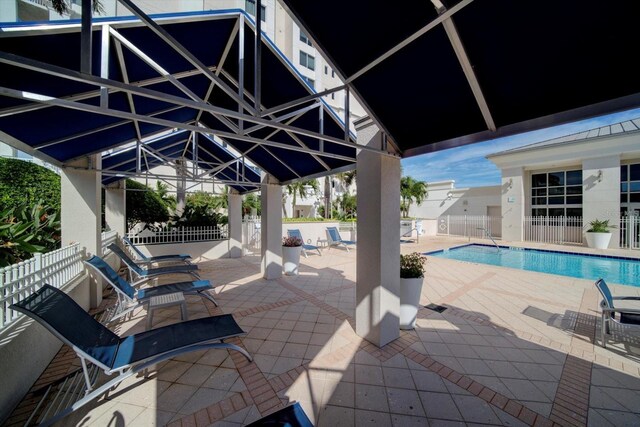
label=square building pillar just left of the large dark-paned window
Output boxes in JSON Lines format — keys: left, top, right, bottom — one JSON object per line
{"left": 502, "top": 168, "right": 531, "bottom": 242}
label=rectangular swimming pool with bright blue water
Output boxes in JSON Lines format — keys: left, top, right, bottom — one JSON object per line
{"left": 425, "top": 244, "right": 640, "bottom": 287}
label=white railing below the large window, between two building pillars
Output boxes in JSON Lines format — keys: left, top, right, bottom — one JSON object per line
{"left": 522, "top": 216, "right": 584, "bottom": 244}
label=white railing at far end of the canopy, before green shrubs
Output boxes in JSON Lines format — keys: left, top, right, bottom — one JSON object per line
{"left": 127, "top": 225, "right": 229, "bottom": 245}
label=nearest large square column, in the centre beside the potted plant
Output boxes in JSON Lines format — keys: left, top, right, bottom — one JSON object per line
{"left": 356, "top": 122, "right": 400, "bottom": 347}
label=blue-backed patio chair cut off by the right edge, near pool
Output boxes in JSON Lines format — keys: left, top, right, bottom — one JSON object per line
{"left": 596, "top": 279, "right": 640, "bottom": 347}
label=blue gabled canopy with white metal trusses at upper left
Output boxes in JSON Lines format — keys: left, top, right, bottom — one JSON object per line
{"left": 0, "top": 10, "right": 356, "bottom": 187}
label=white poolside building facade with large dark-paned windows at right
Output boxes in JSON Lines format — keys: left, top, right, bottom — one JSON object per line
{"left": 487, "top": 119, "right": 640, "bottom": 248}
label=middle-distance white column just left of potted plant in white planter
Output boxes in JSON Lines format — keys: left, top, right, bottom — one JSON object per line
{"left": 260, "top": 173, "right": 282, "bottom": 279}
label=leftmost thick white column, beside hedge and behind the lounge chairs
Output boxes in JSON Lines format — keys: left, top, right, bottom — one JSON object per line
{"left": 61, "top": 155, "right": 102, "bottom": 307}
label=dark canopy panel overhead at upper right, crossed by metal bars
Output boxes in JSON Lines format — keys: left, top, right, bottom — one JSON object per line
{"left": 283, "top": 0, "right": 640, "bottom": 157}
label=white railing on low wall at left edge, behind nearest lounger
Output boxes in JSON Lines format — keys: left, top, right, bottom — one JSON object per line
{"left": 0, "top": 243, "right": 84, "bottom": 330}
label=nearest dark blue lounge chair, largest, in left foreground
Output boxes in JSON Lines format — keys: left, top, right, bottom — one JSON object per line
{"left": 11, "top": 285, "right": 252, "bottom": 425}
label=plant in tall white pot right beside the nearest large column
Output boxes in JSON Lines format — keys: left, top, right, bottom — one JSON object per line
{"left": 400, "top": 252, "right": 427, "bottom": 329}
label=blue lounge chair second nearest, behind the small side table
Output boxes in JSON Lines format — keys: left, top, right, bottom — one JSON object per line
{"left": 84, "top": 256, "right": 218, "bottom": 321}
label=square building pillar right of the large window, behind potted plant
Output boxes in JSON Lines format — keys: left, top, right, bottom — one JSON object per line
{"left": 582, "top": 154, "right": 620, "bottom": 248}
